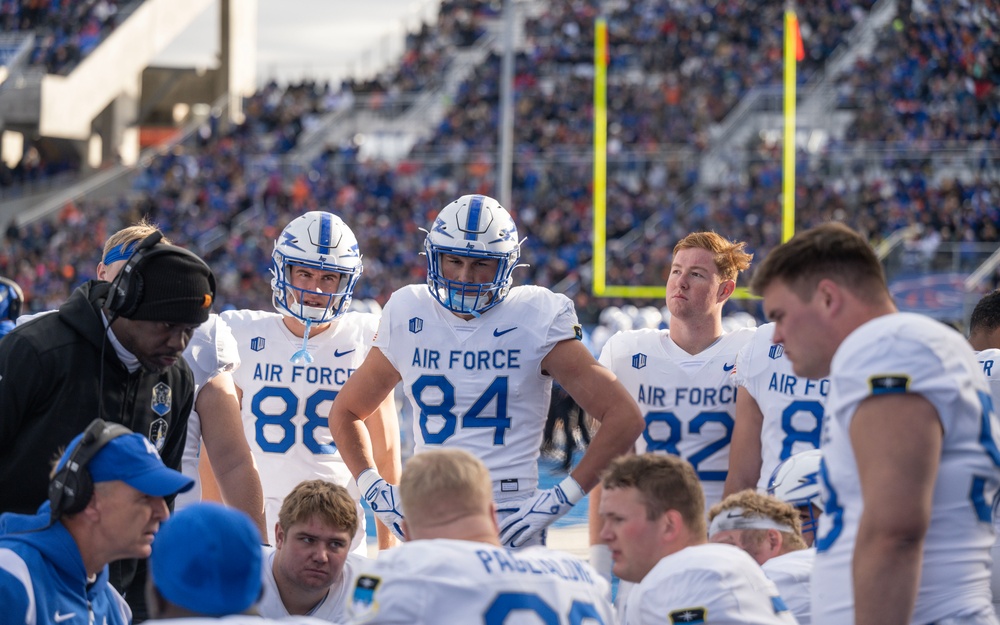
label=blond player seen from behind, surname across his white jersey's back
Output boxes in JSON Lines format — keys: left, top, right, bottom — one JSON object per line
{"left": 347, "top": 449, "right": 615, "bottom": 625}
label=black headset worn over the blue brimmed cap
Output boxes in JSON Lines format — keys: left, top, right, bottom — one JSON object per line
{"left": 49, "top": 419, "right": 132, "bottom": 521}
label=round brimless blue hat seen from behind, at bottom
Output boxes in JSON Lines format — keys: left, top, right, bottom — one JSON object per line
{"left": 149, "top": 502, "right": 263, "bottom": 616}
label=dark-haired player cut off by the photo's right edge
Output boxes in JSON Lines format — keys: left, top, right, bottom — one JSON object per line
{"left": 969, "top": 290, "right": 1000, "bottom": 617}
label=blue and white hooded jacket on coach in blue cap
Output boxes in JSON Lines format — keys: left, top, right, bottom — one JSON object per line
{"left": 0, "top": 502, "right": 132, "bottom": 625}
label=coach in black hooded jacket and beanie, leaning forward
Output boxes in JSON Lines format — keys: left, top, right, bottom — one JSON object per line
{"left": 0, "top": 244, "right": 215, "bottom": 622}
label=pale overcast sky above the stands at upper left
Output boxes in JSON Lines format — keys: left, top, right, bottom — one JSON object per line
{"left": 155, "top": 0, "right": 440, "bottom": 84}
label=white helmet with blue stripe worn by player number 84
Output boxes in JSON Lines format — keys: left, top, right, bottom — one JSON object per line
{"left": 424, "top": 195, "right": 521, "bottom": 316}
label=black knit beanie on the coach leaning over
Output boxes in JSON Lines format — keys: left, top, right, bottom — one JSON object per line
{"left": 122, "top": 254, "right": 215, "bottom": 325}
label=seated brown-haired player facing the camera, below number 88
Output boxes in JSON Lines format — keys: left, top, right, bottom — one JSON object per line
{"left": 257, "top": 480, "right": 368, "bottom": 623}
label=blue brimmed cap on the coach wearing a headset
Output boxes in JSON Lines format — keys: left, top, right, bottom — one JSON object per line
{"left": 56, "top": 433, "right": 194, "bottom": 497}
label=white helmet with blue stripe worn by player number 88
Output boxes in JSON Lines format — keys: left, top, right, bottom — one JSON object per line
{"left": 271, "top": 211, "right": 362, "bottom": 323}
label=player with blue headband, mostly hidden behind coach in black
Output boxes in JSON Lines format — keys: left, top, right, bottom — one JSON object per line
{"left": 18, "top": 220, "right": 267, "bottom": 536}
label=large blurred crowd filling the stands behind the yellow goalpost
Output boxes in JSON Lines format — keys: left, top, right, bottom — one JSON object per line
{"left": 0, "top": 2, "right": 1000, "bottom": 316}
